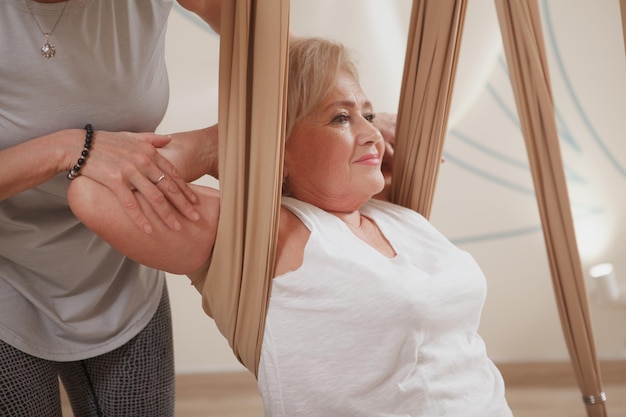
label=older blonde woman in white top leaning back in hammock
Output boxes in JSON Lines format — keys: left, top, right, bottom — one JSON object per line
{"left": 70, "top": 39, "right": 511, "bottom": 417}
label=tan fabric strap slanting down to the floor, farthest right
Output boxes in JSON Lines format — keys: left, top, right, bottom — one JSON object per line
{"left": 496, "top": 0, "right": 606, "bottom": 417}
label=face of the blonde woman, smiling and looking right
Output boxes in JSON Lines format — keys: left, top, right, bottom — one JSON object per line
{"left": 284, "top": 72, "right": 384, "bottom": 212}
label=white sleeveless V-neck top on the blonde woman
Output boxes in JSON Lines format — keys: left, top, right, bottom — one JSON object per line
{"left": 258, "top": 198, "right": 512, "bottom": 417}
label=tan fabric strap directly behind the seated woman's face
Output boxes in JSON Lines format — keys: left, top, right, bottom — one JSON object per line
{"left": 391, "top": 0, "right": 467, "bottom": 217}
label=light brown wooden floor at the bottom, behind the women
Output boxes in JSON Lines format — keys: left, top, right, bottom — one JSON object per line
{"left": 63, "top": 362, "right": 626, "bottom": 417}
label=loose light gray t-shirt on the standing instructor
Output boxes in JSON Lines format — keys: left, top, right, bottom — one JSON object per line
{"left": 0, "top": 0, "right": 172, "bottom": 361}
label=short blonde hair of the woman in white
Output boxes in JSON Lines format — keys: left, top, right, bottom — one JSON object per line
{"left": 285, "top": 37, "right": 358, "bottom": 139}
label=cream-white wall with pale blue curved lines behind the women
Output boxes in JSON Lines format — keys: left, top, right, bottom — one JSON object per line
{"left": 160, "top": 0, "right": 626, "bottom": 372}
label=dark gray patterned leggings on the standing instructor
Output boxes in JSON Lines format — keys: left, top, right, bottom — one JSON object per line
{"left": 0, "top": 289, "right": 174, "bottom": 417}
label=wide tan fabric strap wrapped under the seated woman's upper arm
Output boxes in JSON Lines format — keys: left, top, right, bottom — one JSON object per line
{"left": 193, "top": 0, "right": 289, "bottom": 376}
